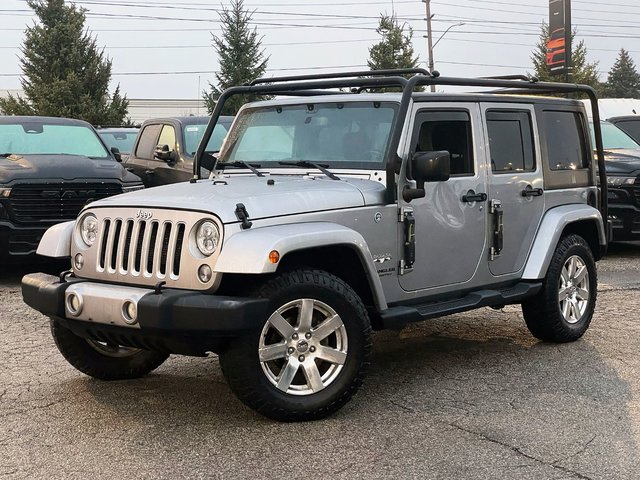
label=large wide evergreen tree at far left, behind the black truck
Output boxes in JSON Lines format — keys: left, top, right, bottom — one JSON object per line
{"left": 0, "top": 0, "right": 129, "bottom": 125}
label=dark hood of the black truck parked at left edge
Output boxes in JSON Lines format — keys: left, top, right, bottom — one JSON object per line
{"left": 0, "top": 155, "right": 139, "bottom": 184}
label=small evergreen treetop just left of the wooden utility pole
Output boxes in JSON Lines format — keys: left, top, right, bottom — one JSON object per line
{"left": 367, "top": 15, "right": 418, "bottom": 70}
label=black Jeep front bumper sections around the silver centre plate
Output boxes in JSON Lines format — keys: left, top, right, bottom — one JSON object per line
{"left": 22, "top": 273, "right": 269, "bottom": 355}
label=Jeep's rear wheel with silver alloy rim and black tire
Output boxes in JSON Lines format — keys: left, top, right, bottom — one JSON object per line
{"left": 522, "top": 235, "right": 598, "bottom": 343}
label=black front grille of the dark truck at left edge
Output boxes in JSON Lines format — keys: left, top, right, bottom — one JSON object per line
{"left": 9, "top": 183, "right": 122, "bottom": 224}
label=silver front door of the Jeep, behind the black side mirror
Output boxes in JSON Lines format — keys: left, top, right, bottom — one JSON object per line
{"left": 399, "top": 102, "right": 486, "bottom": 291}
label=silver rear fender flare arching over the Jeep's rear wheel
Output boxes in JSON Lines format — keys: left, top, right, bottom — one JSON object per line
{"left": 522, "top": 205, "right": 607, "bottom": 280}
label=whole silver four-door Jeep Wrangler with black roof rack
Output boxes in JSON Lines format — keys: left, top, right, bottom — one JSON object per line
{"left": 22, "top": 70, "right": 608, "bottom": 421}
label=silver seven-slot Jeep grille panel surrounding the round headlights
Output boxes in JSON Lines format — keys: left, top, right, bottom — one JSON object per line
{"left": 71, "top": 207, "right": 224, "bottom": 292}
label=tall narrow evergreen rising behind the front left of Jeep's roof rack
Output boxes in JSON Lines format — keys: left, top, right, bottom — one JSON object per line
{"left": 203, "top": 0, "right": 269, "bottom": 115}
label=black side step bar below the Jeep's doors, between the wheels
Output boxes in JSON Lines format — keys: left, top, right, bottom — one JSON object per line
{"left": 380, "top": 282, "right": 542, "bottom": 329}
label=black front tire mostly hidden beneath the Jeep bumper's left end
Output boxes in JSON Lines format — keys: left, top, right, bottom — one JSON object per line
{"left": 51, "top": 320, "right": 169, "bottom": 380}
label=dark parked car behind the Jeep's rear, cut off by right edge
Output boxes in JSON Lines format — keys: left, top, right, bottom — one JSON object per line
{"left": 591, "top": 122, "right": 640, "bottom": 241}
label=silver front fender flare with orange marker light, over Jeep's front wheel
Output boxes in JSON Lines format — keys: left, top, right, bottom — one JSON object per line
{"left": 214, "top": 222, "right": 387, "bottom": 310}
